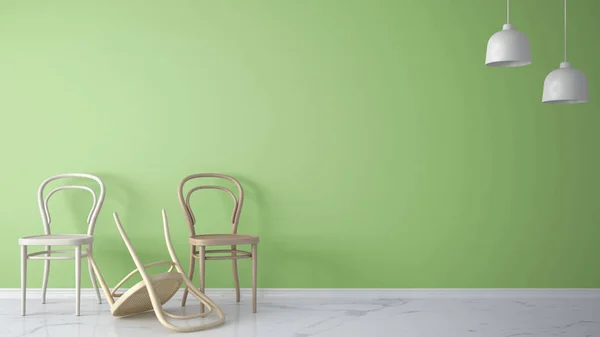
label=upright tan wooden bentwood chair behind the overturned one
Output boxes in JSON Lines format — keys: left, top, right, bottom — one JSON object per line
{"left": 177, "top": 173, "right": 259, "bottom": 312}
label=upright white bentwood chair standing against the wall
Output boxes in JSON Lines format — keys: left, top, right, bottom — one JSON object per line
{"left": 19, "top": 173, "right": 105, "bottom": 316}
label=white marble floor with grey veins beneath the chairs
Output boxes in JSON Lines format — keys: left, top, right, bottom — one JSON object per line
{"left": 0, "top": 297, "right": 600, "bottom": 337}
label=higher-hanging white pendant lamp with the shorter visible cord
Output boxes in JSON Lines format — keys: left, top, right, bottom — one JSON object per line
{"left": 485, "top": 0, "right": 531, "bottom": 67}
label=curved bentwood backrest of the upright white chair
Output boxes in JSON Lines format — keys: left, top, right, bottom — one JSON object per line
{"left": 38, "top": 173, "right": 105, "bottom": 235}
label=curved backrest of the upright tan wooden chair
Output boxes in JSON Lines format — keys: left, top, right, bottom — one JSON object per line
{"left": 177, "top": 173, "right": 244, "bottom": 236}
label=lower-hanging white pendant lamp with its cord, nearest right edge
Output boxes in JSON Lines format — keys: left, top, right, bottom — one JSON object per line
{"left": 542, "top": 0, "right": 590, "bottom": 104}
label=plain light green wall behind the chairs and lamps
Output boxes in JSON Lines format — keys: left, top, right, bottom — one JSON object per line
{"left": 0, "top": 0, "right": 600, "bottom": 288}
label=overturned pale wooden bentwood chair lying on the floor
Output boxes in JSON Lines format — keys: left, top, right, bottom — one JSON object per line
{"left": 89, "top": 209, "right": 225, "bottom": 332}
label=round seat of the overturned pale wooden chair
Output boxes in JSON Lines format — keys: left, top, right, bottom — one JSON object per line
{"left": 111, "top": 272, "right": 183, "bottom": 317}
